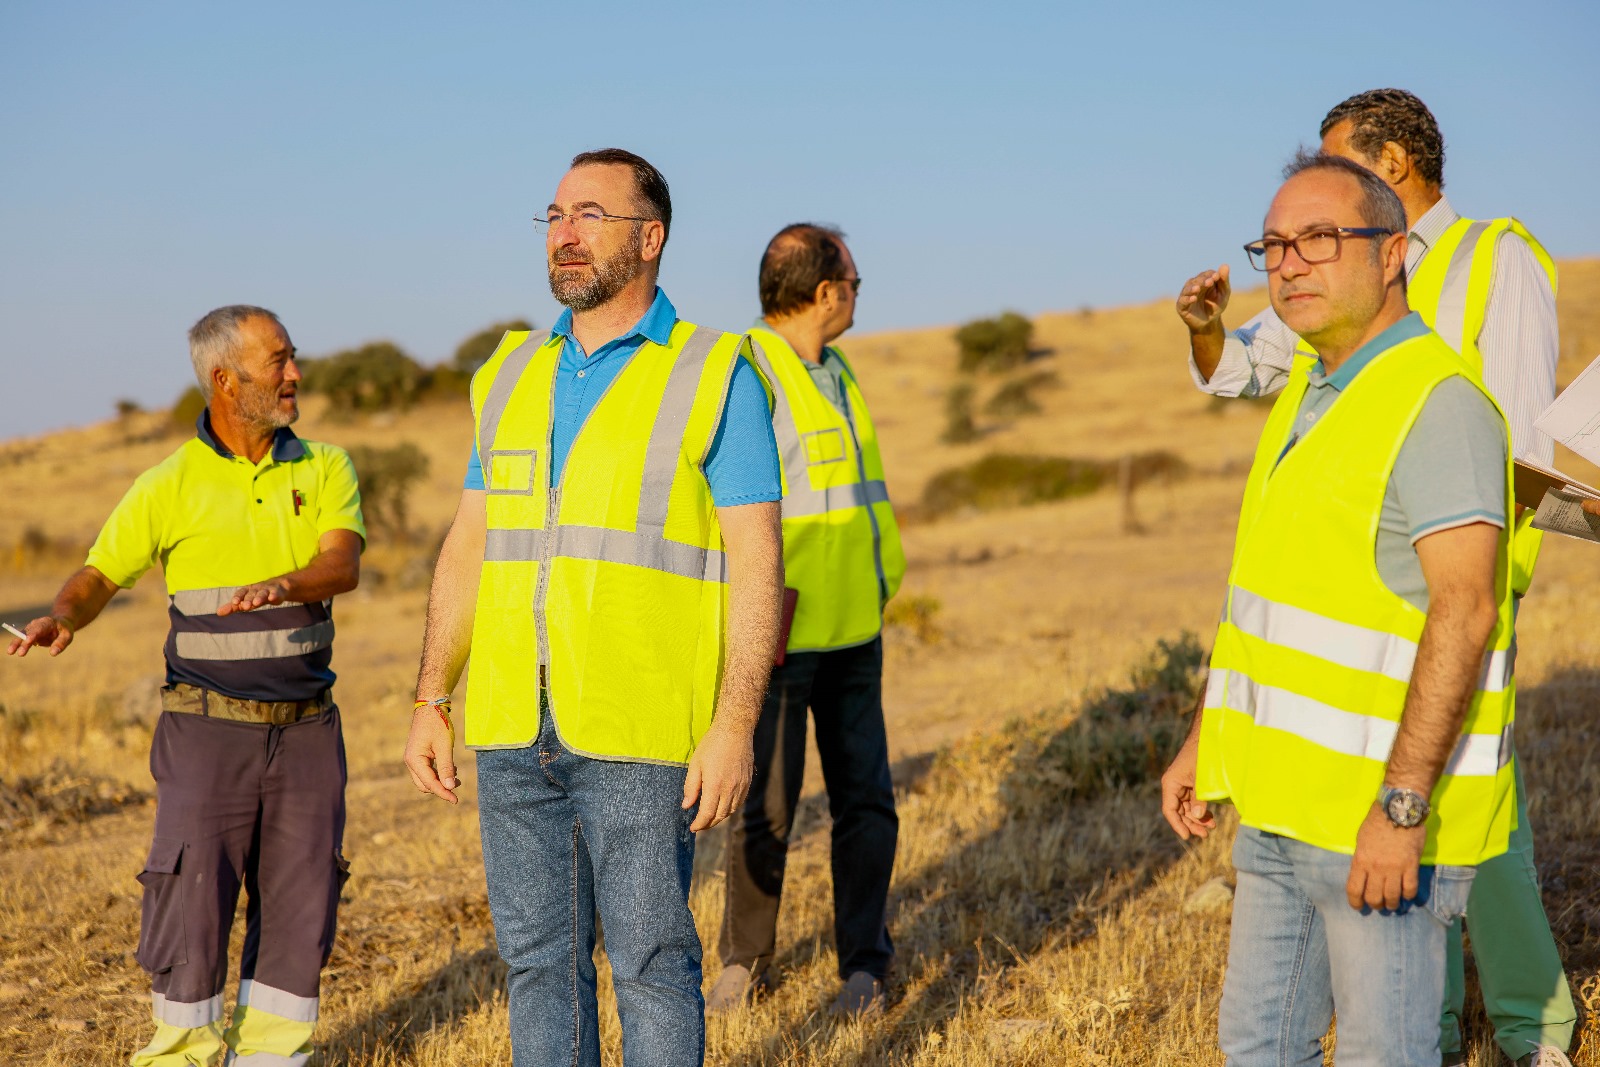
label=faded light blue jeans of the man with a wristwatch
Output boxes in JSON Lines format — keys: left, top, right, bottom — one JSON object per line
{"left": 1218, "top": 827, "right": 1475, "bottom": 1067}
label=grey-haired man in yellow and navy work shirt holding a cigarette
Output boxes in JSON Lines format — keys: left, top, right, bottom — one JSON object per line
{"left": 8, "top": 304, "right": 366, "bottom": 1067}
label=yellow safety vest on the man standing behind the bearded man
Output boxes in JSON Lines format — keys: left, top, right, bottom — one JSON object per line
{"left": 749, "top": 328, "right": 906, "bottom": 653}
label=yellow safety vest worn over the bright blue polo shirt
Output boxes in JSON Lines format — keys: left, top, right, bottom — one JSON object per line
{"left": 466, "top": 322, "right": 747, "bottom": 763}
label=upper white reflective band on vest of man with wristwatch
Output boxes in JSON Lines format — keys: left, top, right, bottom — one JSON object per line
{"left": 1229, "top": 585, "right": 1514, "bottom": 693}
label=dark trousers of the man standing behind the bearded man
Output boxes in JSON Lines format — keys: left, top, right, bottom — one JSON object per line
{"left": 720, "top": 638, "right": 899, "bottom": 979}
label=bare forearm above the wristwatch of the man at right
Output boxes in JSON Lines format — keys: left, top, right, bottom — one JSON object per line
{"left": 1384, "top": 597, "right": 1496, "bottom": 797}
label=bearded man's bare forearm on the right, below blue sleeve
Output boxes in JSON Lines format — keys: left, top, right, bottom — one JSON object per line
{"left": 717, "top": 504, "right": 784, "bottom": 729}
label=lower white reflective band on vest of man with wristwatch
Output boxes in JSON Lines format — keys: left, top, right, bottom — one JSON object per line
{"left": 1205, "top": 669, "right": 1512, "bottom": 777}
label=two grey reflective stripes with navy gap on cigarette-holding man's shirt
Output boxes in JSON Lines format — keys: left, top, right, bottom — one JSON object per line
{"left": 166, "top": 585, "right": 333, "bottom": 661}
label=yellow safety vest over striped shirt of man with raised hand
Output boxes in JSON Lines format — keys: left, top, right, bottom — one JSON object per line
{"left": 1406, "top": 219, "right": 1557, "bottom": 597}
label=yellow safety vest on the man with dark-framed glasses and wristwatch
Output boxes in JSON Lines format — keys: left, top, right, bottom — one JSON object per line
{"left": 1195, "top": 333, "right": 1515, "bottom": 865}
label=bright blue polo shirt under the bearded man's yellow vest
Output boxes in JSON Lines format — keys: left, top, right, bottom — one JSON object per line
{"left": 464, "top": 288, "right": 784, "bottom": 507}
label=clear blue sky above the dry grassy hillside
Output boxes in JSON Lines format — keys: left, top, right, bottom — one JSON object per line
{"left": 0, "top": 0, "right": 1600, "bottom": 438}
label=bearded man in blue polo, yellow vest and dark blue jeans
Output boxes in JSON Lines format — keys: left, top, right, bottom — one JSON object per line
{"left": 405, "top": 149, "right": 782, "bottom": 1067}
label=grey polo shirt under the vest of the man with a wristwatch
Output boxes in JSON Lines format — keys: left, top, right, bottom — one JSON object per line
{"left": 1278, "top": 312, "right": 1506, "bottom": 611}
